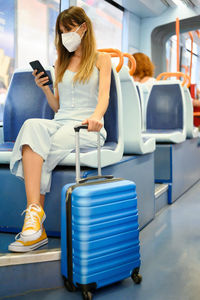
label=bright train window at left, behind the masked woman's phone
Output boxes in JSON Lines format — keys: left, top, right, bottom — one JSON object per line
{"left": 0, "top": 0, "right": 60, "bottom": 121}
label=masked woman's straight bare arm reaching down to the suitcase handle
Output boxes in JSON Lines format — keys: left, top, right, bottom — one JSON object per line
{"left": 82, "top": 53, "right": 111, "bottom": 131}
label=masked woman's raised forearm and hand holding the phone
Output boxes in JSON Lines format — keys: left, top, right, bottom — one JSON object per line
{"left": 33, "top": 62, "right": 59, "bottom": 112}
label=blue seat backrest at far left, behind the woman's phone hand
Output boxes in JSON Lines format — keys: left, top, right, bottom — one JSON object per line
{"left": 3, "top": 70, "right": 54, "bottom": 142}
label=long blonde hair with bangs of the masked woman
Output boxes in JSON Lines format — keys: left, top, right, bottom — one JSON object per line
{"left": 55, "top": 6, "right": 97, "bottom": 85}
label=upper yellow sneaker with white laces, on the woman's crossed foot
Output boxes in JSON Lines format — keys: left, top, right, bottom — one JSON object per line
{"left": 20, "top": 204, "right": 46, "bottom": 242}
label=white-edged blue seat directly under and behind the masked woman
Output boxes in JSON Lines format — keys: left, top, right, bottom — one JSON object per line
{"left": 59, "top": 65, "right": 124, "bottom": 168}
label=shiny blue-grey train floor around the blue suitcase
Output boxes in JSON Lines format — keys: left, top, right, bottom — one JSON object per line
{"left": 0, "top": 182, "right": 200, "bottom": 300}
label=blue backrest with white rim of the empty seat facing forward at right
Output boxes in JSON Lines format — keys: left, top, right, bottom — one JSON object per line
{"left": 146, "top": 81, "right": 185, "bottom": 130}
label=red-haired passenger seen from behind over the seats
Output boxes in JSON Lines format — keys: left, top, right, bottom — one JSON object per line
{"left": 129, "top": 52, "right": 156, "bottom": 86}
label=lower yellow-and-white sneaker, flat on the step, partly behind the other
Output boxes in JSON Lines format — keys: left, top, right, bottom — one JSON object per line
{"left": 8, "top": 228, "right": 48, "bottom": 252}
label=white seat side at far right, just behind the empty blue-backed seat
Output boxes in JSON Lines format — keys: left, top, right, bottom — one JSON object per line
{"left": 183, "top": 86, "right": 199, "bottom": 139}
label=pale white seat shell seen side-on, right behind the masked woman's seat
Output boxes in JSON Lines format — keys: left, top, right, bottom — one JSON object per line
{"left": 119, "top": 66, "right": 155, "bottom": 154}
